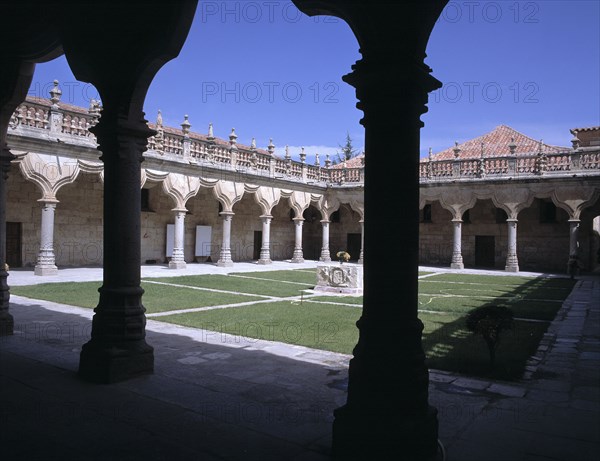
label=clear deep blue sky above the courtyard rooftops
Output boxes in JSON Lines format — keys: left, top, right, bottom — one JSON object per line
{"left": 30, "top": 0, "right": 600, "bottom": 161}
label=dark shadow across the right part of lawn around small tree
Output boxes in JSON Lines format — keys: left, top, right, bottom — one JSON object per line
{"left": 419, "top": 277, "right": 575, "bottom": 381}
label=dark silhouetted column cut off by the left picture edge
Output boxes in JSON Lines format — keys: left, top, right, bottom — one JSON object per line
{"left": 0, "top": 150, "right": 15, "bottom": 336}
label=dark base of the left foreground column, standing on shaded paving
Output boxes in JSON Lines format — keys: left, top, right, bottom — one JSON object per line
{"left": 79, "top": 339, "right": 154, "bottom": 384}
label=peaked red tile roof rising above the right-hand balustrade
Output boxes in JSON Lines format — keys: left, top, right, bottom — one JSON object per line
{"left": 422, "top": 125, "right": 569, "bottom": 161}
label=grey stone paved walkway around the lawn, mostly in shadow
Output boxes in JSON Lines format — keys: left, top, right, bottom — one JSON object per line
{"left": 0, "top": 263, "right": 600, "bottom": 461}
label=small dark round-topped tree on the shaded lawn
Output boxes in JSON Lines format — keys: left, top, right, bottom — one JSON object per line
{"left": 467, "top": 305, "right": 514, "bottom": 368}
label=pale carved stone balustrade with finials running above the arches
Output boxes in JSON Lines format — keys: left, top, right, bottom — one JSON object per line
{"left": 9, "top": 94, "right": 600, "bottom": 186}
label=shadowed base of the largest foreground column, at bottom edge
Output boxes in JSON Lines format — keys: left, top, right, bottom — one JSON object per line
{"left": 332, "top": 405, "right": 438, "bottom": 461}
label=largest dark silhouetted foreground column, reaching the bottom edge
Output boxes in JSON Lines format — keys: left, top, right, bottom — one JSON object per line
{"left": 332, "top": 53, "right": 440, "bottom": 461}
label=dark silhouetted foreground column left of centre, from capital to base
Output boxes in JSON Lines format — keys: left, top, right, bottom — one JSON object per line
{"left": 79, "top": 108, "right": 155, "bottom": 383}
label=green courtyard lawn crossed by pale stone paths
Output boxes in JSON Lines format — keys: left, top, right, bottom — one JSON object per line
{"left": 11, "top": 270, "right": 575, "bottom": 380}
